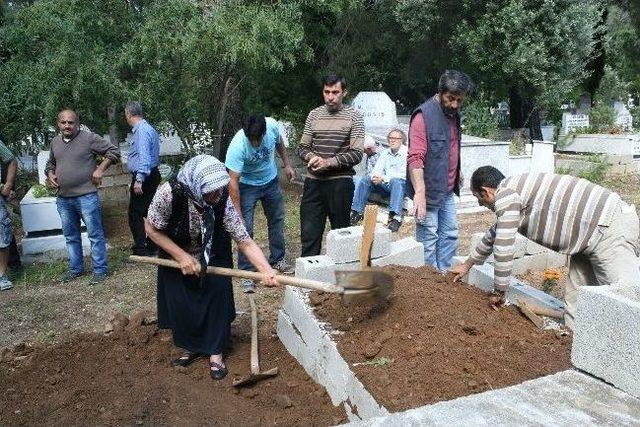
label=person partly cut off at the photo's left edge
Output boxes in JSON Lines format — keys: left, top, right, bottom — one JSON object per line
{"left": 0, "top": 140, "right": 18, "bottom": 291}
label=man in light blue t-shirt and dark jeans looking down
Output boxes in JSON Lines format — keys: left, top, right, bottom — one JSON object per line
{"left": 225, "top": 115, "right": 295, "bottom": 292}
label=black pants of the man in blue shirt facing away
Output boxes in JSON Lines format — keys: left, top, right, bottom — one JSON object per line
{"left": 129, "top": 168, "right": 161, "bottom": 255}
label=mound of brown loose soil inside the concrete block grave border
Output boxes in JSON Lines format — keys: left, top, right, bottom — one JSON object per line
{"left": 310, "top": 266, "right": 571, "bottom": 412}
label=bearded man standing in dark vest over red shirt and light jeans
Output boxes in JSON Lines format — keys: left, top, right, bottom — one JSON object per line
{"left": 407, "top": 70, "right": 472, "bottom": 271}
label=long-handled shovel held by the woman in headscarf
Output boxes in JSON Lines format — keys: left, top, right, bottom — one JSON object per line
{"left": 129, "top": 255, "right": 393, "bottom": 305}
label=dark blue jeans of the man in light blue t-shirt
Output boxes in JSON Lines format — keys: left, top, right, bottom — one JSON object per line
{"left": 238, "top": 176, "right": 285, "bottom": 270}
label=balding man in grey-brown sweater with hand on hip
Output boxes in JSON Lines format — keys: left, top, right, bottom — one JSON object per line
{"left": 44, "top": 109, "right": 120, "bottom": 284}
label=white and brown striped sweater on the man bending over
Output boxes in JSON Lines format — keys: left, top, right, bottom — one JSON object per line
{"left": 469, "top": 173, "right": 621, "bottom": 291}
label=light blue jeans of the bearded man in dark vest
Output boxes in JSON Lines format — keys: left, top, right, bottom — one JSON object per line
{"left": 416, "top": 192, "right": 458, "bottom": 272}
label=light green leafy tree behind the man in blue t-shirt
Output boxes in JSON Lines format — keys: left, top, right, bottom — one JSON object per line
{"left": 123, "top": 0, "right": 310, "bottom": 155}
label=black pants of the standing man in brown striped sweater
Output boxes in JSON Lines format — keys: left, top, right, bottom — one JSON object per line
{"left": 300, "top": 177, "right": 353, "bottom": 257}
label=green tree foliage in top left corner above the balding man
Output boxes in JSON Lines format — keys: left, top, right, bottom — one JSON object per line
{"left": 0, "top": 0, "right": 134, "bottom": 150}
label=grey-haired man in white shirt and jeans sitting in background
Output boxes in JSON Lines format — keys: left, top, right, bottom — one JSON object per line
{"left": 351, "top": 128, "right": 407, "bottom": 232}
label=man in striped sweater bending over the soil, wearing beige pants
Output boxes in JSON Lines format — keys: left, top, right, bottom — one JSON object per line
{"left": 451, "top": 166, "right": 640, "bottom": 329}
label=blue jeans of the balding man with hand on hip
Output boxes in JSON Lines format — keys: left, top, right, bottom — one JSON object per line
{"left": 56, "top": 192, "right": 107, "bottom": 274}
